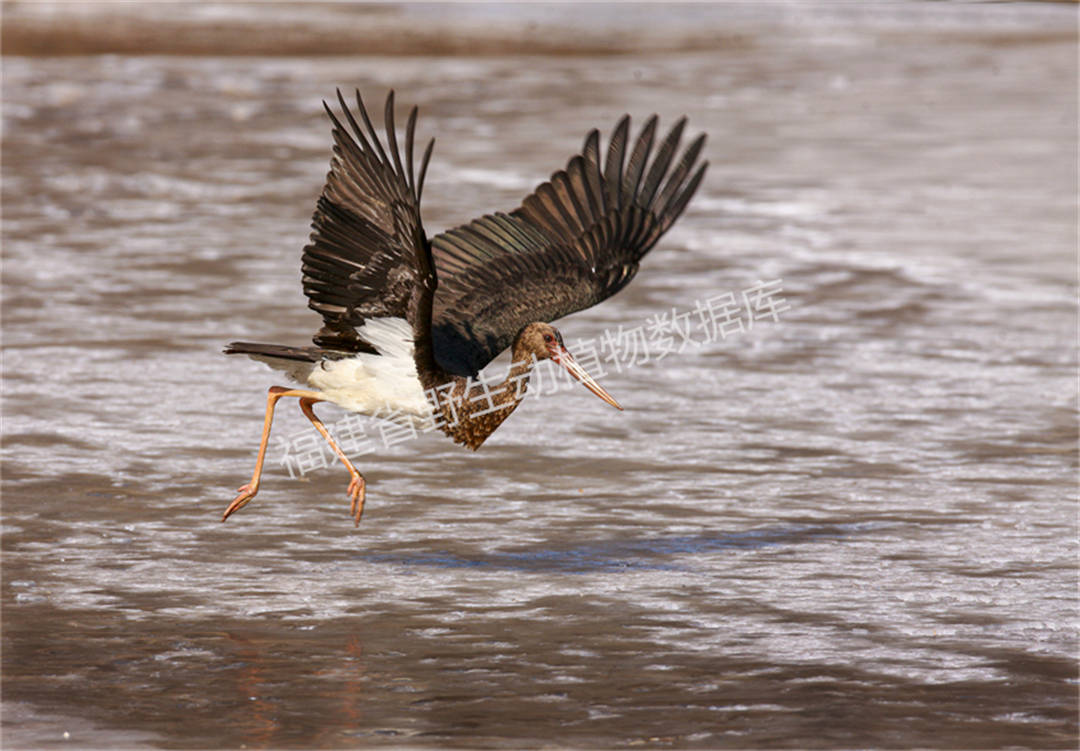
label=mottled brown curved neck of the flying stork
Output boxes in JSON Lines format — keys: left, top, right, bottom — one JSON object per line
{"left": 436, "top": 343, "right": 536, "bottom": 451}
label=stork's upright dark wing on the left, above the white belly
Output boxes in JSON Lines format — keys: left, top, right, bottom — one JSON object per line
{"left": 302, "top": 91, "right": 436, "bottom": 367}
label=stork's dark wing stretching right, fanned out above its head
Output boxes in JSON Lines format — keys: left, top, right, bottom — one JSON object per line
{"left": 431, "top": 115, "right": 708, "bottom": 375}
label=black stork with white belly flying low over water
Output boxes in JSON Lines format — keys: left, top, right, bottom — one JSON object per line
{"left": 221, "top": 91, "right": 707, "bottom": 524}
